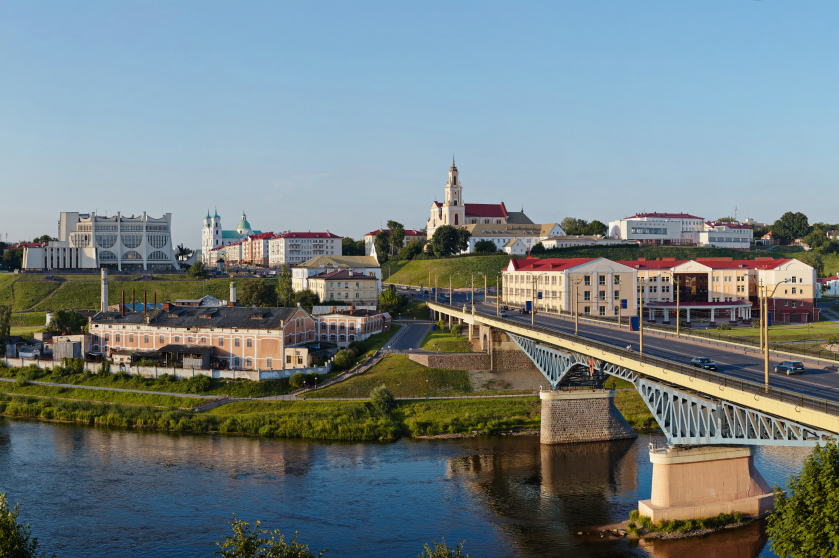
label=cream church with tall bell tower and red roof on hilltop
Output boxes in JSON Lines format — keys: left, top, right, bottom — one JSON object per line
{"left": 427, "top": 157, "right": 533, "bottom": 240}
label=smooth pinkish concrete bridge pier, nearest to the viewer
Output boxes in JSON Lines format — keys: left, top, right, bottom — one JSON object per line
{"left": 638, "top": 446, "right": 775, "bottom": 522}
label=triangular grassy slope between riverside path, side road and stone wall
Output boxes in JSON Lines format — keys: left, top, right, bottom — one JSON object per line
{"left": 306, "top": 355, "right": 472, "bottom": 399}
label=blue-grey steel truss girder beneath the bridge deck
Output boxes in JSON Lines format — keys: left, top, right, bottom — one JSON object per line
{"left": 507, "top": 332, "right": 836, "bottom": 447}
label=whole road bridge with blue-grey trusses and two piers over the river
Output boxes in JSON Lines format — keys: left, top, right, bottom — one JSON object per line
{"left": 428, "top": 302, "right": 839, "bottom": 521}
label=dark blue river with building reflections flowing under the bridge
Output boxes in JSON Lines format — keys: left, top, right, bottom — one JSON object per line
{"left": 0, "top": 417, "right": 809, "bottom": 558}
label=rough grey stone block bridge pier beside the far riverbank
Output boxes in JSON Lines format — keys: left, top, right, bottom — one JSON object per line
{"left": 539, "top": 389, "right": 638, "bottom": 444}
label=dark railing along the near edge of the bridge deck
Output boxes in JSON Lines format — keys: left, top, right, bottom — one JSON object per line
{"left": 434, "top": 303, "right": 839, "bottom": 416}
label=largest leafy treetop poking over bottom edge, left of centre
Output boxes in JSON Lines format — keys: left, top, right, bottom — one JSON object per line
{"left": 215, "top": 513, "right": 327, "bottom": 558}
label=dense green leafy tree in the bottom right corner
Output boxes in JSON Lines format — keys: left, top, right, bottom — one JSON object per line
{"left": 766, "top": 441, "right": 839, "bottom": 557}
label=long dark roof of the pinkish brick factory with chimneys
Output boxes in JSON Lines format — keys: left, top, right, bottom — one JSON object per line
{"left": 91, "top": 306, "right": 299, "bottom": 329}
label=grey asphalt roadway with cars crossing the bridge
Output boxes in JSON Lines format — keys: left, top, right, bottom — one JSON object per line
{"left": 408, "top": 289, "right": 839, "bottom": 401}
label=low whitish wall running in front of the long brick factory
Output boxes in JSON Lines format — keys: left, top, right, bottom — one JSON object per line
{"left": 4, "top": 358, "right": 332, "bottom": 381}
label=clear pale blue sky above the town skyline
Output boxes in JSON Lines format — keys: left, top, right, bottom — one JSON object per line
{"left": 0, "top": 0, "right": 839, "bottom": 248}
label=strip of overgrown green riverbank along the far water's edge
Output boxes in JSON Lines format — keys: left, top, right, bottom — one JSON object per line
{"left": 0, "top": 395, "right": 540, "bottom": 441}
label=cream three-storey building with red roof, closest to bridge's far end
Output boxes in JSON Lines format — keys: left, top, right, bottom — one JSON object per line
{"left": 502, "top": 258, "right": 637, "bottom": 317}
